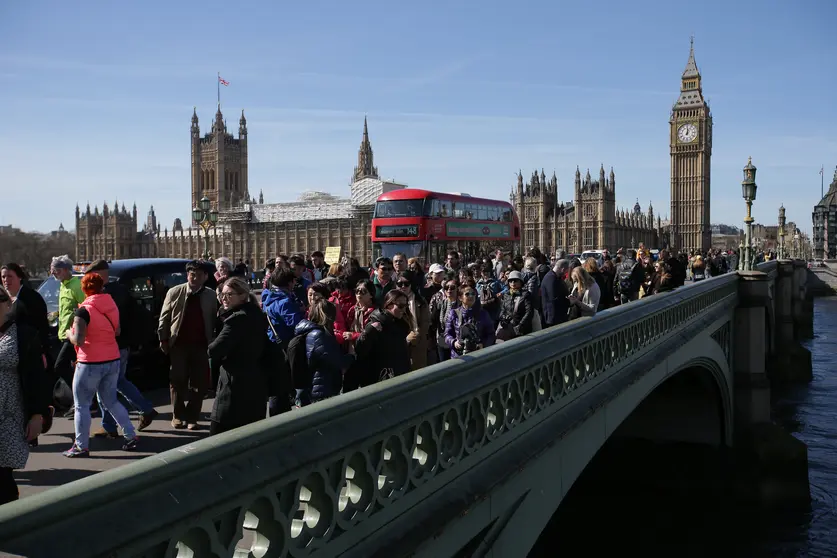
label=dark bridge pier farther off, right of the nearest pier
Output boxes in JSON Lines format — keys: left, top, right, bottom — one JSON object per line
{"left": 767, "top": 260, "right": 813, "bottom": 383}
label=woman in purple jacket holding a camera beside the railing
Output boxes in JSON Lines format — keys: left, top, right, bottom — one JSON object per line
{"left": 445, "top": 285, "right": 494, "bottom": 358}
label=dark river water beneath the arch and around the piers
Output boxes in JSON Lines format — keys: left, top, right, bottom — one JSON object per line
{"left": 530, "top": 297, "right": 837, "bottom": 558}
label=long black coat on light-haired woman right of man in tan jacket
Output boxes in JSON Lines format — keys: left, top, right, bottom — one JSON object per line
{"left": 207, "top": 301, "right": 268, "bottom": 430}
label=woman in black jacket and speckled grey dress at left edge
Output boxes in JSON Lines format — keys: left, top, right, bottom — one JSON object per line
{"left": 0, "top": 287, "right": 52, "bottom": 505}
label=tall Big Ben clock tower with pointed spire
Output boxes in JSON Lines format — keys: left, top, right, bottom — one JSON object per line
{"left": 669, "top": 39, "right": 712, "bottom": 252}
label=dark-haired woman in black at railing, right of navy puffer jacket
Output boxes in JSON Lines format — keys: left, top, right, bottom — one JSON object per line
{"left": 355, "top": 289, "right": 410, "bottom": 386}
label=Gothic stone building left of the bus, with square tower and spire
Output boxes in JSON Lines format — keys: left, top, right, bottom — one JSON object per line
{"left": 76, "top": 114, "right": 384, "bottom": 266}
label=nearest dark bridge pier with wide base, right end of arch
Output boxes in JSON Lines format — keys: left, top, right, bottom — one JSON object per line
{"left": 733, "top": 271, "right": 811, "bottom": 507}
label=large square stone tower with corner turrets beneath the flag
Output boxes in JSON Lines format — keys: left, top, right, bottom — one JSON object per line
{"left": 191, "top": 107, "right": 250, "bottom": 222}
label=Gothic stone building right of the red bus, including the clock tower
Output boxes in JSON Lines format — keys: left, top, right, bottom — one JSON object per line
{"left": 509, "top": 43, "right": 712, "bottom": 254}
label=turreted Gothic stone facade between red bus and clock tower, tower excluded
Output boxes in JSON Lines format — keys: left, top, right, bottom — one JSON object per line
{"left": 510, "top": 165, "right": 662, "bottom": 254}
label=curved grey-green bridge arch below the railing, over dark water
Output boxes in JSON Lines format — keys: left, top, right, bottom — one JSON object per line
{"left": 424, "top": 324, "right": 734, "bottom": 558}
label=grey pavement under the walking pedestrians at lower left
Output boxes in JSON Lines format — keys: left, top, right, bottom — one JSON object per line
{"left": 15, "top": 390, "right": 213, "bottom": 498}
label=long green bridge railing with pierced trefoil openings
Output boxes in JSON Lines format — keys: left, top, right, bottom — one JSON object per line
{"left": 0, "top": 273, "right": 738, "bottom": 558}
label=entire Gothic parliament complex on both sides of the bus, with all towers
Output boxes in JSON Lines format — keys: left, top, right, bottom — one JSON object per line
{"left": 75, "top": 39, "right": 712, "bottom": 265}
